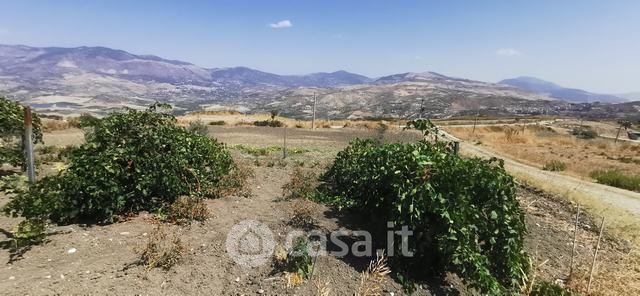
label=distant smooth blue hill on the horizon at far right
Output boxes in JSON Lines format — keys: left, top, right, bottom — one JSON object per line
{"left": 498, "top": 76, "right": 627, "bottom": 103}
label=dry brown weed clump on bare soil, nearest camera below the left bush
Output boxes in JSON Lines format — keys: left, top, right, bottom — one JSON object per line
{"left": 139, "top": 225, "right": 186, "bottom": 270}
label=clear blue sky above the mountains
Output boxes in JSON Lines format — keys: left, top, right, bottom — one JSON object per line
{"left": 0, "top": 0, "right": 640, "bottom": 93}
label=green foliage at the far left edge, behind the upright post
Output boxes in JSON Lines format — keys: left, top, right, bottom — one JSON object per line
{"left": 0, "top": 97, "right": 42, "bottom": 166}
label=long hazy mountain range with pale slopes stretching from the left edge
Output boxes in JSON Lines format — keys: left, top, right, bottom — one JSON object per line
{"left": 0, "top": 45, "right": 632, "bottom": 118}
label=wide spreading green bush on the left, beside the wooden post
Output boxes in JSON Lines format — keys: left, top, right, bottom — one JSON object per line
{"left": 4, "top": 104, "right": 234, "bottom": 222}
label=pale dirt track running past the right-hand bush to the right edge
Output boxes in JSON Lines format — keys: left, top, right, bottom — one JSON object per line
{"left": 442, "top": 131, "right": 640, "bottom": 219}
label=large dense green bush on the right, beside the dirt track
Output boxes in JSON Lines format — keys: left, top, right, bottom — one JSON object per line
{"left": 322, "top": 140, "right": 528, "bottom": 295}
